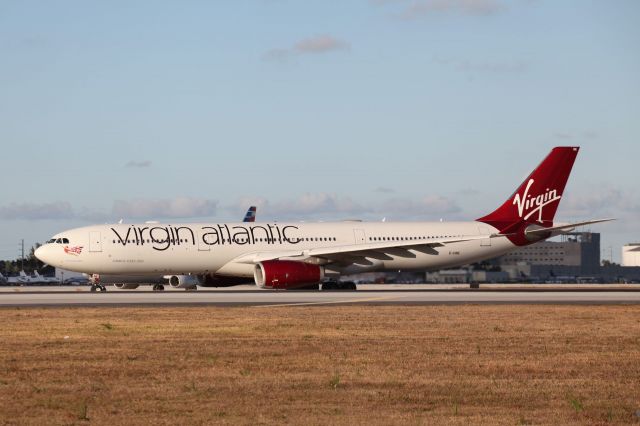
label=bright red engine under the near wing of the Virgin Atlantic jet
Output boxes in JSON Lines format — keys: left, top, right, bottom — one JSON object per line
{"left": 253, "top": 260, "right": 324, "bottom": 289}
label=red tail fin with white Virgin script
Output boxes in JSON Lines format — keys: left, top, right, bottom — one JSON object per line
{"left": 477, "top": 146, "right": 580, "bottom": 233}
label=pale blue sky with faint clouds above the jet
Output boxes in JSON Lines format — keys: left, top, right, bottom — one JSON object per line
{"left": 0, "top": 0, "right": 640, "bottom": 261}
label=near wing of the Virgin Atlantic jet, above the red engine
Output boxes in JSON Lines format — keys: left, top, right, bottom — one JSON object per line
{"left": 233, "top": 234, "right": 503, "bottom": 265}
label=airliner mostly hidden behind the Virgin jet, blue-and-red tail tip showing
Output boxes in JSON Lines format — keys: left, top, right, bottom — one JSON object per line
{"left": 76, "top": 206, "right": 257, "bottom": 291}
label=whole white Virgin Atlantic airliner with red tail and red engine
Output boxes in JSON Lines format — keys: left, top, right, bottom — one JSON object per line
{"left": 35, "top": 146, "right": 612, "bottom": 291}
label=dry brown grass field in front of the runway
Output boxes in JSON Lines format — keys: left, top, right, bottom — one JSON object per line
{"left": 0, "top": 305, "right": 640, "bottom": 425}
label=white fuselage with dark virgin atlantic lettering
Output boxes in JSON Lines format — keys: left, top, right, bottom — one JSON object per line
{"left": 33, "top": 221, "right": 515, "bottom": 277}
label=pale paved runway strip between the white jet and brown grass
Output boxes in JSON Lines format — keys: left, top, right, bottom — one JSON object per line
{"left": 0, "top": 286, "right": 640, "bottom": 307}
